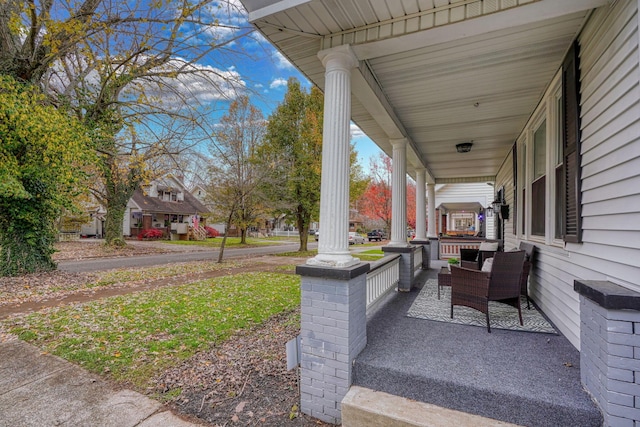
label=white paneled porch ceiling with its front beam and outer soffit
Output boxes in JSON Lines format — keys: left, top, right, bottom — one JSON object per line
{"left": 242, "top": 0, "right": 607, "bottom": 183}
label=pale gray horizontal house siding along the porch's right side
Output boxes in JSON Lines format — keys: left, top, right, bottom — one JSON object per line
{"left": 497, "top": 1, "right": 640, "bottom": 349}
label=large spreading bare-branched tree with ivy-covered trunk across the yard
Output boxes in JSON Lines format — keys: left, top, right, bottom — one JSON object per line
{"left": 0, "top": 0, "right": 252, "bottom": 245}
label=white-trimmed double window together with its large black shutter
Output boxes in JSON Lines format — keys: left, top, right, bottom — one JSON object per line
{"left": 514, "top": 43, "right": 582, "bottom": 244}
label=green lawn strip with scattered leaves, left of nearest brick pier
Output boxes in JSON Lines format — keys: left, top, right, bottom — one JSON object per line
{"left": 3, "top": 273, "right": 300, "bottom": 388}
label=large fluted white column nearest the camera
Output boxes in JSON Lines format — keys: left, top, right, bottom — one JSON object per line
{"left": 307, "top": 45, "right": 360, "bottom": 268}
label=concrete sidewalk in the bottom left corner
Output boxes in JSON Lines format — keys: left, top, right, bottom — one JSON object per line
{"left": 0, "top": 340, "right": 203, "bottom": 427}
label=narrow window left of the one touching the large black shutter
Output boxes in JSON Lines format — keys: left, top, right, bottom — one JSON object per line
{"left": 531, "top": 119, "right": 547, "bottom": 236}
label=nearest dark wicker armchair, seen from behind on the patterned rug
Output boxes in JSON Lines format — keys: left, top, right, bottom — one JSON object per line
{"left": 451, "top": 251, "right": 525, "bottom": 332}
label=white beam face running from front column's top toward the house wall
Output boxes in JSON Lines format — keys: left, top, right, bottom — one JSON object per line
{"left": 350, "top": 0, "right": 610, "bottom": 60}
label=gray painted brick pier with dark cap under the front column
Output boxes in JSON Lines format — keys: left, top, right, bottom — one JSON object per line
{"left": 296, "top": 263, "right": 369, "bottom": 424}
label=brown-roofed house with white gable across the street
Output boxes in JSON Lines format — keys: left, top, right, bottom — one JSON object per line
{"left": 122, "top": 176, "right": 209, "bottom": 239}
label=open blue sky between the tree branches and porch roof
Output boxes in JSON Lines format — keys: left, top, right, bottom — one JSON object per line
{"left": 196, "top": 0, "right": 380, "bottom": 171}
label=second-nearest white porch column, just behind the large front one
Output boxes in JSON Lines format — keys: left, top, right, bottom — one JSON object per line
{"left": 389, "top": 138, "right": 408, "bottom": 246}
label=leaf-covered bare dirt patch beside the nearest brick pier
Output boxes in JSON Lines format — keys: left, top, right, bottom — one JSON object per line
{"left": 154, "top": 311, "right": 330, "bottom": 427}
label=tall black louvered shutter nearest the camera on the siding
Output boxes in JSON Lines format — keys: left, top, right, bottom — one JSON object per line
{"left": 562, "top": 41, "right": 582, "bottom": 243}
